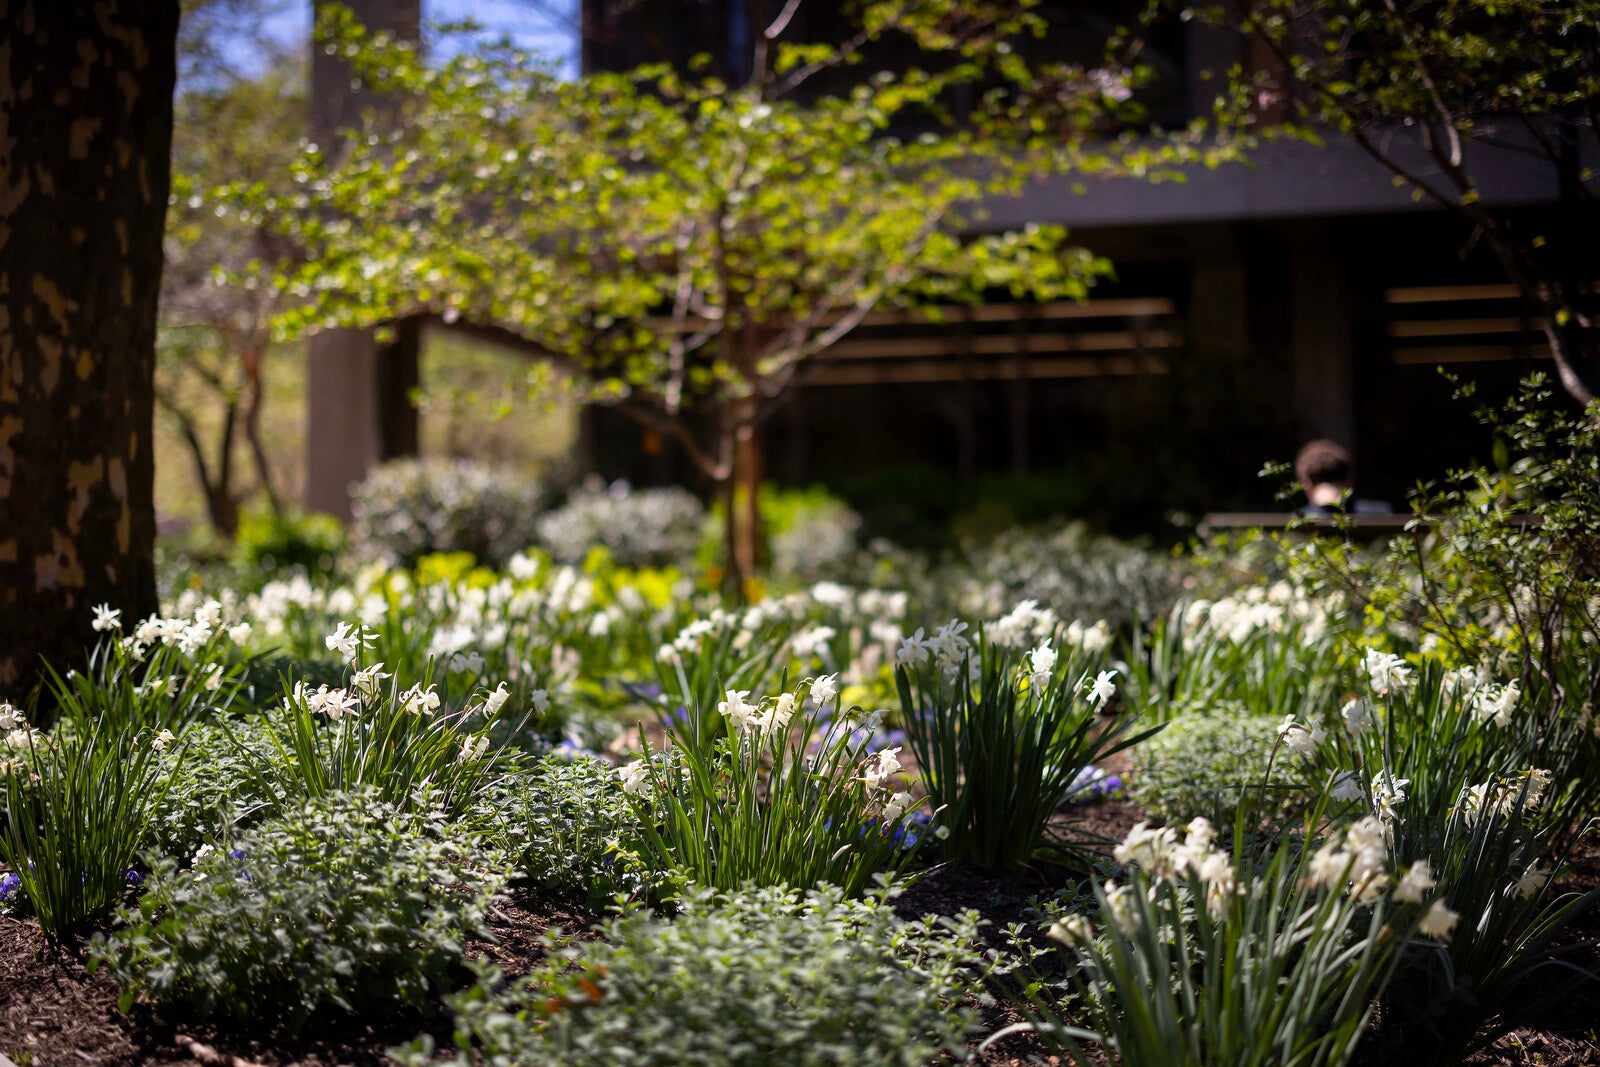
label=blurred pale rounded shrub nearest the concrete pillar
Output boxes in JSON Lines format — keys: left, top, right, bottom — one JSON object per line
{"left": 350, "top": 458, "right": 539, "bottom": 566}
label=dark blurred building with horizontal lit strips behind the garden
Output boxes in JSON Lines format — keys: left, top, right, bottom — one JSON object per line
{"left": 582, "top": 0, "right": 1560, "bottom": 528}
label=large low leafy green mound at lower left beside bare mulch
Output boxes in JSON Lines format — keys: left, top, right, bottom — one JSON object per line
{"left": 90, "top": 792, "right": 504, "bottom": 1025}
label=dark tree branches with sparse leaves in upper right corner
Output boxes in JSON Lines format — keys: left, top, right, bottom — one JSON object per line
{"left": 1187, "top": 0, "right": 1600, "bottom": 405}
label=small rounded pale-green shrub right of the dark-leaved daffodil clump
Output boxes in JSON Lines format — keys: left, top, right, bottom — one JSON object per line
{"left": 1131, "top": 707, "right": 1290, "bottom": 824}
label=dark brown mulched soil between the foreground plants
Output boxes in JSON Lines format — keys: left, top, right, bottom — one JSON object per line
{"left": 0, "top": 800, "right": 1600, "bottom": 1067}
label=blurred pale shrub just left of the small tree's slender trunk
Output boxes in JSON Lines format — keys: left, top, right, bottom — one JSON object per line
{"left": 538, "top": 482, "right": 706, "bottom": 566}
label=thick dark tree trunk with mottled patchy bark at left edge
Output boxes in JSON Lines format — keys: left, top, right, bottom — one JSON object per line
{"left": 0, "top": 0, "right": 178, "bottom": 699}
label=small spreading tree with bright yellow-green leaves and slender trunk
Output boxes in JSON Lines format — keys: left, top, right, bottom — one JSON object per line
{"left": 265, "top": 0, "right": 1230, "bottom": 579}
